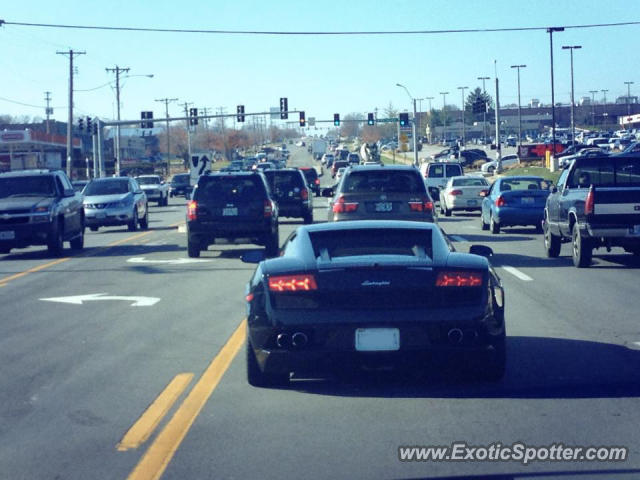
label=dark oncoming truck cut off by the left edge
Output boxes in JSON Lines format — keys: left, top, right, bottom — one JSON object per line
{"left": 0, "top": 170, "right": 84, "bottom": 256}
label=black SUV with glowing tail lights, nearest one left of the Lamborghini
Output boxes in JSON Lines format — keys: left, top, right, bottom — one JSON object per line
{"left": 182, "top": 171, "right": 278, "bottom": 257}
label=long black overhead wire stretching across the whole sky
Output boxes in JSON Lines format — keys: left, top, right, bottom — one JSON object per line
{"left": 0, "top": 19, "right": 640, "bottom": 35}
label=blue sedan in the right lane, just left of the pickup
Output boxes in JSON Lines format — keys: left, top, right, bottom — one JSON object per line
{"left": 480, "top": 176, "right": 549, "bottom": 233}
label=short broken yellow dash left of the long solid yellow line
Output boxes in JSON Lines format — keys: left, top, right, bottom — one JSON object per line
{"left": 116, "top": 373, "right": 193, "bottom": 452}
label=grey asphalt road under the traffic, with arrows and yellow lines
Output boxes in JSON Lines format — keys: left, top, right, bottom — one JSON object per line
{"left": 0, "top": 147, "right": 640, "bottom": 479}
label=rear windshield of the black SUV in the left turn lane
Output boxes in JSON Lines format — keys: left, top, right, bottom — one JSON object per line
{"left": 195, "top": 175, "right": 266, "bottom": 201}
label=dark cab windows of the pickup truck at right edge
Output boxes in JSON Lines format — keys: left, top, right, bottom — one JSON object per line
{"left": 567, "top": 157, "right": 640, "bottom": 188}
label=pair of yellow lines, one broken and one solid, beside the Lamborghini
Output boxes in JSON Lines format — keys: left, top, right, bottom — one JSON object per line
{"left": 124, "top": 320, "right": 247, "bottom": 480}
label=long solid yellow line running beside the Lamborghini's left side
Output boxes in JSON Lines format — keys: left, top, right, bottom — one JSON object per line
{"left": 128, "top": 320, "right": 247, "bottom": 480}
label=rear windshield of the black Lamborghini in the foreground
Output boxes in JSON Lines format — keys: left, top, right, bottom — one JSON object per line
{"left": 309, "top": 228, "right": 433, "bottom": 259}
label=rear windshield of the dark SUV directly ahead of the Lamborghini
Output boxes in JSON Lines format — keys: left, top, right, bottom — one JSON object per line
{"left": 343, "top": 169, "right": 426, "bottom": 194}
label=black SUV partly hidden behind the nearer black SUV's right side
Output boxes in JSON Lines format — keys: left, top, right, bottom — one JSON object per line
{"left": 264, "top": 168, "right": 313, "bottom": 223}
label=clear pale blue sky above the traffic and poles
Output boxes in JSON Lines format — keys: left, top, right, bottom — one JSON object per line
{"left": 0, "top": 0, "right": 640, "bottom": 127}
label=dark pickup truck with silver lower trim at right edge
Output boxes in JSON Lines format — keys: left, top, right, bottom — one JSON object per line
{"left": 542, "top": 155, "right": 640, "bottom": 268}
